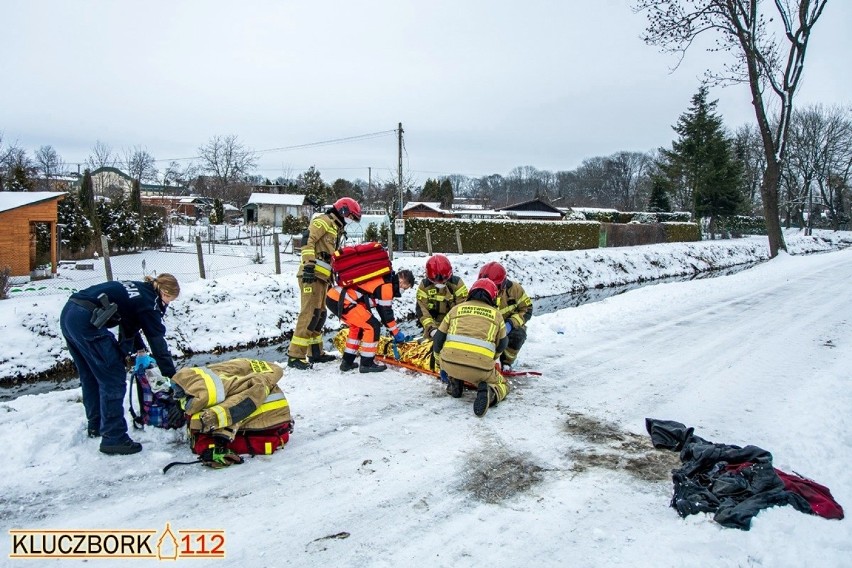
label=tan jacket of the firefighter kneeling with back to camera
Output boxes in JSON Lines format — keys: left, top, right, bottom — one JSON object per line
{"left": 432, "top": 300, "right": 508, "bottom": 379}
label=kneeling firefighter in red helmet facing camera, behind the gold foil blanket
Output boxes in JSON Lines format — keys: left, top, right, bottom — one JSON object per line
{"left": 415, "top": 254, "right": 467, "bottom": 339}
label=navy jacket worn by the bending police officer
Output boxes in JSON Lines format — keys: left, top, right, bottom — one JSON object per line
{"left": 71, "top": 280, "right": 175, "bottom": 377}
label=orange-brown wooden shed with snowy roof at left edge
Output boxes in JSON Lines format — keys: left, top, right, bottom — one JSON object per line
{"left": 0, "top": 191, "right": 66, "bottom": 277}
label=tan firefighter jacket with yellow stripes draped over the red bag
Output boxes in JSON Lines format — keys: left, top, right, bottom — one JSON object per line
{"left": 172, "top": 359, "right": 292, "bottom": 439}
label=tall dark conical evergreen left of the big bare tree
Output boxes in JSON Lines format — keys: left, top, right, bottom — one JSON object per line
{"left": 658, "top": 85, "right": 742, "bottom": 233}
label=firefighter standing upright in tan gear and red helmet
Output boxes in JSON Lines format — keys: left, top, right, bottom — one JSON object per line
{"left": 287, "top": 197, "right": 361, "bottom": 369}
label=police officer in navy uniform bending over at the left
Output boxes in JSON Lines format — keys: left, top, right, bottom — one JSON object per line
{"left": 59, "top": 274, "right": 180, "bottom": 455}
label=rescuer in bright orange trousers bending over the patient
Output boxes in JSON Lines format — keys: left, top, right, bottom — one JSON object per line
{"left": 326, "top": 270, "right": 414, "bottom": 373}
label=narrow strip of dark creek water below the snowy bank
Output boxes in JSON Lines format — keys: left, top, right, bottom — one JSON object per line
{"left": 0, "top": 263, "right": 757, "bottom": 402}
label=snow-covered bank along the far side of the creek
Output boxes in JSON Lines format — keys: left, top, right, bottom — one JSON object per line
{"left": 0, "top": 231, "right": 852, "bottom": 381}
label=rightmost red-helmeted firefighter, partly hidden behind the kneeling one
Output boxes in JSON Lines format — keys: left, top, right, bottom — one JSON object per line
{"left": 479, "top": 262, "right": 532, "bottom": 372}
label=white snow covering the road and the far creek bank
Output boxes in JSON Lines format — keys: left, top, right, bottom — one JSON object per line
{"left": 0, "top": 230, "right": 852, "bottom": 567}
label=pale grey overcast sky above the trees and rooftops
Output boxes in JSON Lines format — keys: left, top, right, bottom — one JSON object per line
{"left": 0, "top": 0, "right": 852, "bottom": 182}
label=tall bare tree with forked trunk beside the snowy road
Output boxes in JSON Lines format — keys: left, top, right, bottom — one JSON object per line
{"left": 634, "top": 0, "right": 827, "bottom": 257}
